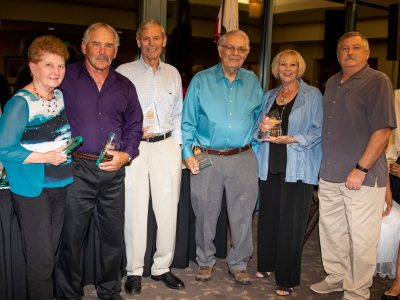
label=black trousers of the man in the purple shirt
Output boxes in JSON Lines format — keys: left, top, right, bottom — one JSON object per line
{"left": 57, "top": 159, "right": 125, "bottom": 299}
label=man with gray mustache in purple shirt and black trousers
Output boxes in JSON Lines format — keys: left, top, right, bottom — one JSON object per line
{"left": 57, "top": 23, "right": 143, "bottom": 299}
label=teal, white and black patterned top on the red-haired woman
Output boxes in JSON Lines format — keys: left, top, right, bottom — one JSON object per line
{"left": 0, "top": 89, "right": 72, "bottom": 197}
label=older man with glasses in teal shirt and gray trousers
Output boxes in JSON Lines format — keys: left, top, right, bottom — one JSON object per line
{"left": 182, "top": 30, "right": 262, "bottom": 285}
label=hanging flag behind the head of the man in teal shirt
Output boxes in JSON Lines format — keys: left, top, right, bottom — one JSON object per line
{"left": 214, "top": 0, "right": 239, "bottom": 41}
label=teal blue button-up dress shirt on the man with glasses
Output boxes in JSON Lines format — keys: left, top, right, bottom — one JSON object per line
{"left": 182, "top": 64, "right": 263, "bottom": 159}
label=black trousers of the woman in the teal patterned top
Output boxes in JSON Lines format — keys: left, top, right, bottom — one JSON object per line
{"left": 11, "top": 188, "right": 66, "bottom": 300}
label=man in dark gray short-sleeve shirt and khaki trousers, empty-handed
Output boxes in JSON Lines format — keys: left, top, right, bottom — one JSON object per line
{"left": 311, "top": 32, "right": 396, "bottom": 300}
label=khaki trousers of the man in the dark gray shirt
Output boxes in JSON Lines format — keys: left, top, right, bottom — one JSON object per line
{"left": 318, "top": 179, "right": 386, "bottom": 300}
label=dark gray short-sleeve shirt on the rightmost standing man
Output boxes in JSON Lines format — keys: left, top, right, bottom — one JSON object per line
{"left": 320, "top": 65, "right": 396, "bottom": 187}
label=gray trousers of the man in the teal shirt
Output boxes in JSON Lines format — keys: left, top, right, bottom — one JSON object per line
{"left": 190, "top": 150, "right": 258, "bottom": 270}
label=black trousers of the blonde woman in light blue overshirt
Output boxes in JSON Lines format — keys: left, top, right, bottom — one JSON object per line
{"left": 257, "top": 173, "right": 314, "bottom": 287}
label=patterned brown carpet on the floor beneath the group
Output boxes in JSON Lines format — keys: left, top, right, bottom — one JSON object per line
{"left": 84, "top": 216, "right": 391, "bottom": 300}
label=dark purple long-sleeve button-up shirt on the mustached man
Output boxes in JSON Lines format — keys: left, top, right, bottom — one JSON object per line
{"left": 60, "top": 62, "right": 143, "bottom": 157}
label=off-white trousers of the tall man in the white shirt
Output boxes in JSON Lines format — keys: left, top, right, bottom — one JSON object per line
{"left": 125, "top": 138, "right": 181, "bottom": 276}
